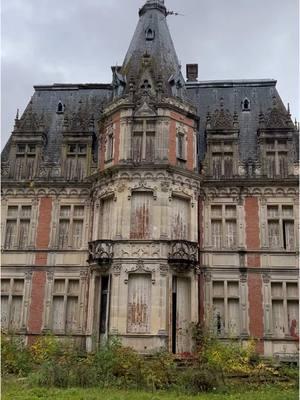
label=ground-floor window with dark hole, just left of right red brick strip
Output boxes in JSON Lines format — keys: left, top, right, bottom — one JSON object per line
{"left": 213, "top": 280, "right": 241, "bottom": 336}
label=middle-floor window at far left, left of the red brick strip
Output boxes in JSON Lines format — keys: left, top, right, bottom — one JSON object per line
{"left": 4, "top": 206, "right": 31, "bottom": 249}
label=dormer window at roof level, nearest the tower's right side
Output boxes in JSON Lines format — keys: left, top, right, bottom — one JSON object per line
{"left": 211, "top": 142, "right": 234, "bottom": 179}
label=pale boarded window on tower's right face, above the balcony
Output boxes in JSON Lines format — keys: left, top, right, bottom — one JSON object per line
{"left": 171, "top": 196, "right": 190, "bottom": 240}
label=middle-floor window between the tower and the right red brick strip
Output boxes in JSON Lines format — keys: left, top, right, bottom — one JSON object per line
{"left": 211, "top": 204, "right": 237, "bottom": 249}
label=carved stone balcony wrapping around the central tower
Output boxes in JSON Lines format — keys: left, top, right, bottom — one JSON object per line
{"left": 88, "top": 239, "right": 198, "bottom": 269}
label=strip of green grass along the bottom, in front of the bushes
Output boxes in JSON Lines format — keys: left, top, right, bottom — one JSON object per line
{"left": 2, "top": 377, "right": 299, "bottom": 400}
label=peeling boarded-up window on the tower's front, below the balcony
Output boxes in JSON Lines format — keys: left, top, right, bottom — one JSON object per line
{"left": 127, "top": 274, "right": 151, "bottom": 333}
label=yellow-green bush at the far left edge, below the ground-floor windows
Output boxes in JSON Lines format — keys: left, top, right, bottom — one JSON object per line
{"left": 1, "top": 334, "right": 33, "bottom": 376}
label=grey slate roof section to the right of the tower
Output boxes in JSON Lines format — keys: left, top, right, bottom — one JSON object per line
{"left": 186, "top": 79, "right": 296, "bottom": 161}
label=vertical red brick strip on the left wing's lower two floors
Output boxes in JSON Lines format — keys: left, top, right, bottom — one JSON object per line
{"left": 28, "top": 197, "right": 52, "bottom": 336}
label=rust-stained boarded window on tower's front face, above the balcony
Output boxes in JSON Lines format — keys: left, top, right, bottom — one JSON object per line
{"left": 130, "top": 192, "right": 153, "bottom": 239}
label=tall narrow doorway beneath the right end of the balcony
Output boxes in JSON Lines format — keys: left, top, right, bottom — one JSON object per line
{"left": 172, "top": 276, "right": 191, "bottom": 353}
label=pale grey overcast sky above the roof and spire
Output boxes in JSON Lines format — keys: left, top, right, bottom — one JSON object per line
{"left": 1, "top": 0, "right": 300, "bottom": 147}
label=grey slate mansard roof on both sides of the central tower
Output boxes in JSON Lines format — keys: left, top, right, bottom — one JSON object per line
{"left": 2, "top": 80, "right": 298, "bottom": 163}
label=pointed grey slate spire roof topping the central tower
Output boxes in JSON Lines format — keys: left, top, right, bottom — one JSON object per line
{"left": 118, "top": 0, "right": 185, "bottom": 98}
